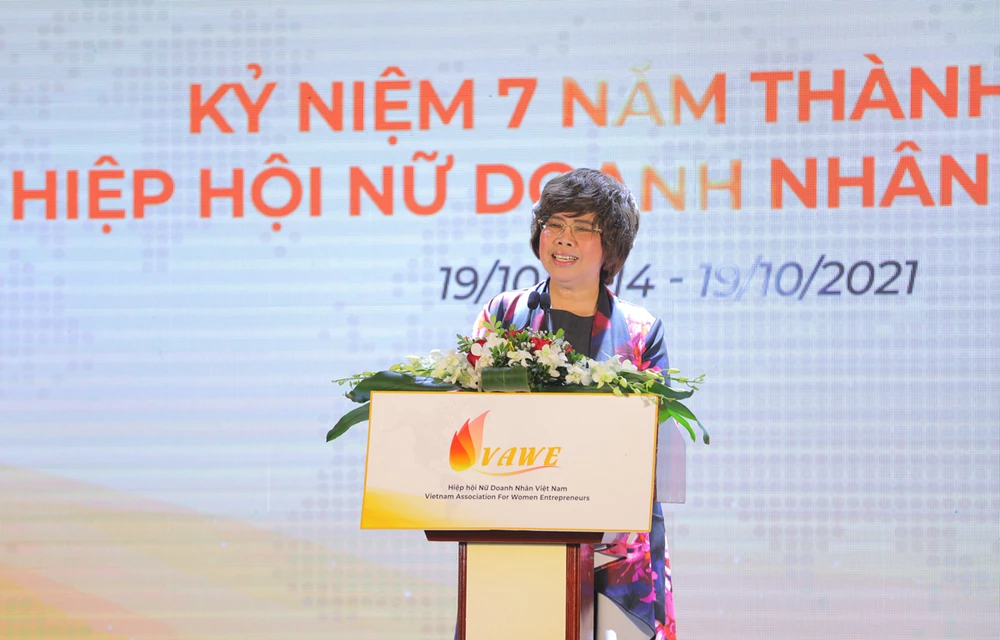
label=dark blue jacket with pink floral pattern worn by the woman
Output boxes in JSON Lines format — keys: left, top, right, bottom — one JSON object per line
{"left": 472, "top": 280, "right": 676, "bottom": 640}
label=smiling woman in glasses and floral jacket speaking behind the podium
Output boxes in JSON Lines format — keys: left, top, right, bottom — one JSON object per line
{"left": 473, "top": 169, "right": 676, "bottom": 640}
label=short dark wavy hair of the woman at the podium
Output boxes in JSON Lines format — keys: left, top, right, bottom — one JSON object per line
{"left": 531, "top": 169, "right": 639, "bottom": 284}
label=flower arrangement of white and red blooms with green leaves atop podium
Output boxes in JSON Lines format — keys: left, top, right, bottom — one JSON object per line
{"left": 326, "top": 318, "right": 709, "bottom": 444}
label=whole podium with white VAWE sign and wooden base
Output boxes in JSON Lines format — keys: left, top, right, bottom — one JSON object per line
{"left": 361, "top": 392, "right": 683, "bottom": 640}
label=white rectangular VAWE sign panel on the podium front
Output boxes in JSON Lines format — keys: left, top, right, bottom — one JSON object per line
{"left": 361, "top": 392, "right": 657, "bottom": 531}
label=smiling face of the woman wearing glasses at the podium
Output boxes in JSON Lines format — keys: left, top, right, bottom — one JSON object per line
{"left": 538, "top": 213, "right": 604, "bottom": 287}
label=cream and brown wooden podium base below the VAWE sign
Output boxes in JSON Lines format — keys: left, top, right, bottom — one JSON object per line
{"left": 426, "top": 531, "right": 601, "bottom": 640}
